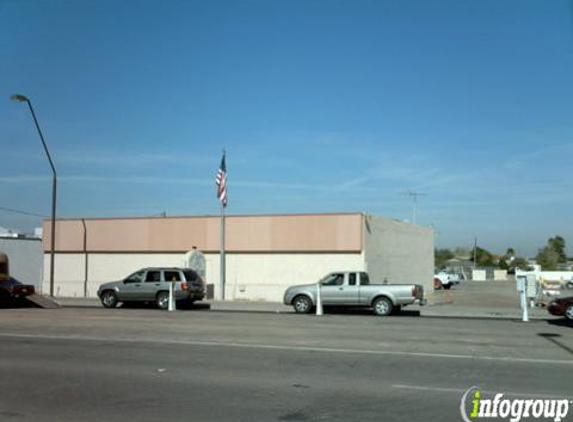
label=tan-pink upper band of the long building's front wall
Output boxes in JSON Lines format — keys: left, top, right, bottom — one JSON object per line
{"left": 44, "top": 213, "right": 363, "bottom": 253}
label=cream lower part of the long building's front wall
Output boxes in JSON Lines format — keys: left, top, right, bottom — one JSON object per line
{"left": 44, "top": 252, "right": 364, "bottom": 302}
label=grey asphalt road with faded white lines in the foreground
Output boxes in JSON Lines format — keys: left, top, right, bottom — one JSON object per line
{"left": 0, "top": 309, "right": 573, "bottom": 422}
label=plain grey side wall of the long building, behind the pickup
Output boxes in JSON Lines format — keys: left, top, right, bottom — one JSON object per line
{"left": 364, "top": 216, "right": 434, "bottom": 293}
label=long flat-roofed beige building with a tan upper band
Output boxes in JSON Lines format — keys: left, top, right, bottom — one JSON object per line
{"left": 43, "top": 213, "right": 434, "bottom": 301}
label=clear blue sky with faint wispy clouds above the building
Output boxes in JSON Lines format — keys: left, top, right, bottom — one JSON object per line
{"left": 0, "top": 0, "right": 573, "bottom": 254}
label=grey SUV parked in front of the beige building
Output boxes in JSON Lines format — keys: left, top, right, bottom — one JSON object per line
{"left": 97, "top": 268, "right": 205, "bottom": 309}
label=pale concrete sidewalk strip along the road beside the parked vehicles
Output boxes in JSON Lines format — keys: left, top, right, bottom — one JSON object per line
{"left": 56, "top": 298, "right": 555, "bottom": 320}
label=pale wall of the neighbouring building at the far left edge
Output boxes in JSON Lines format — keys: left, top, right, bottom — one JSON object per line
{"left": 0, "top": 238, "right": 42, "bottom": 289}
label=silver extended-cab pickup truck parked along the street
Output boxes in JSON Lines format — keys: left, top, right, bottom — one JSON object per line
{"left": 284, "top": 272, "right": 426, "bottom": 316}
